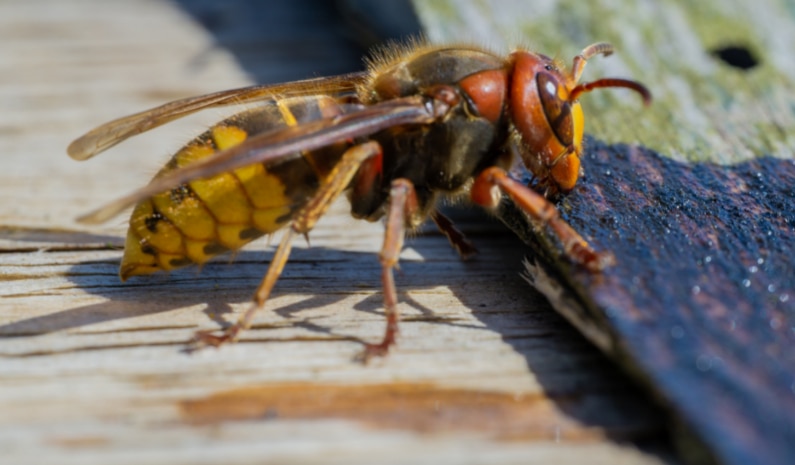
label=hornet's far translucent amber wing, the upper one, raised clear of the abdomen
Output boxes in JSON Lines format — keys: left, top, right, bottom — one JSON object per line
{"left": 66, "top": 72, "right": 367, "bottom": 160}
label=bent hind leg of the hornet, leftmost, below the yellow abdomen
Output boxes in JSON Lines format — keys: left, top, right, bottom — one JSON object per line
{"left": 194, "top": 142, "right": 380, "bottom": 347}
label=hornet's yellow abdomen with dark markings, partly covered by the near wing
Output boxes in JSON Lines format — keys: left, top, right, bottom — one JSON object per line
{"left": 119, "top": 96, "right": 342, "bottom": 280}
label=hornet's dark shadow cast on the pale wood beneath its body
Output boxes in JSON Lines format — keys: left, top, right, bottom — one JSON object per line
{"left": 0, "top": 207, "right": 532, "bottom": 343}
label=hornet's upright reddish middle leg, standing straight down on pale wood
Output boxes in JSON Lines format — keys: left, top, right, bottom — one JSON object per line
{"left": 363, "top": 179, "right": 417, "bottom": 361}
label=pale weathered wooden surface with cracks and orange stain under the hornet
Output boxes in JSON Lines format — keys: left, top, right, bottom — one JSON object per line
{"left": 0, "top": 0, "right": 677, "bottom": 464}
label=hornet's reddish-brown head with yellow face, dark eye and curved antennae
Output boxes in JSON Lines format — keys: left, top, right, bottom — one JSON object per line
{"left": 510, "top": 43, "right": 651, "bottom": 192}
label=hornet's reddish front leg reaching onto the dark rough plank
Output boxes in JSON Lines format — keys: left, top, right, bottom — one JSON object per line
{"left": 471, "top": 167, "right": 614, "bottom": 271}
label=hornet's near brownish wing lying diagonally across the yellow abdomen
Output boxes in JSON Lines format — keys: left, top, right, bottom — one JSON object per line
{"left": 78, "top": 96, "right": 439, "bottom": 224}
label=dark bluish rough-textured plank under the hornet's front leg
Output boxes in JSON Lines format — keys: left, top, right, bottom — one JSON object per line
{"left": 504, "top": 141, "right": 795, "bottom": 463}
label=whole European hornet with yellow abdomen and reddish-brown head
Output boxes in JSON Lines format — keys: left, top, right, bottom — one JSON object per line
{"left": 68, "top": 43, "right": 651, "bottom": 357}
